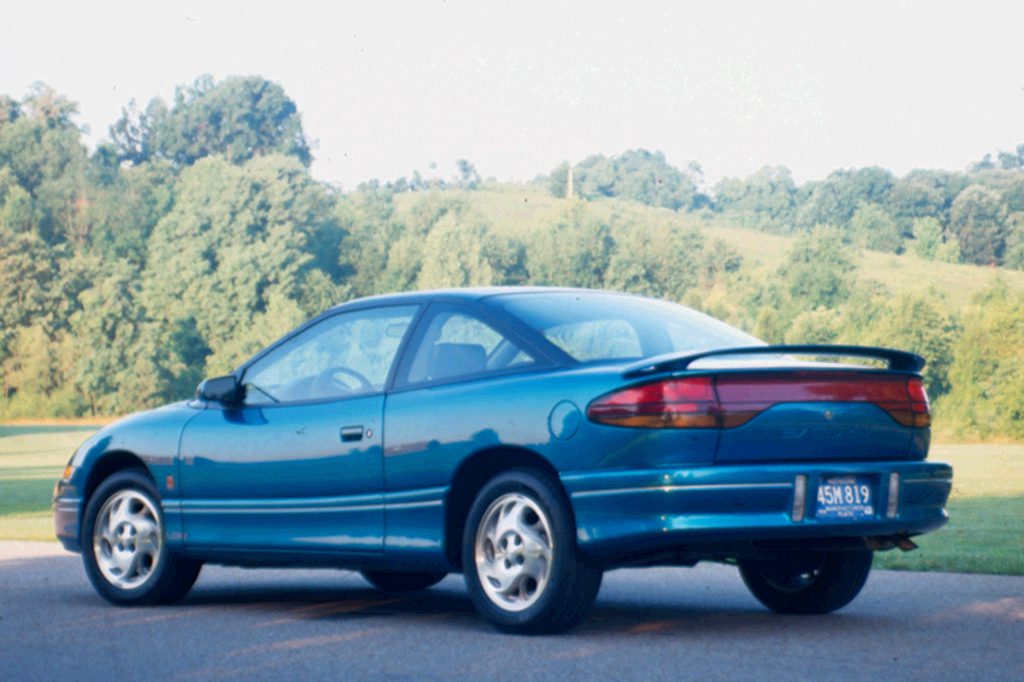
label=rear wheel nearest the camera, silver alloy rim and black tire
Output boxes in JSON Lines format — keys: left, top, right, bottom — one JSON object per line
{"left": 462, "top": 469, "right": 601, "bottom": 634}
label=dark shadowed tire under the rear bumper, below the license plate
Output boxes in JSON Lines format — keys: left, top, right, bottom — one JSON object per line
{"left": 739, "top": 550, "right": 874, "bottom": 613}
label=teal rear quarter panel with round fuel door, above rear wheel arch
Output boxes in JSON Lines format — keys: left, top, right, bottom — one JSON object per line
{"left": 384, "top": 368, "right": 718, "bottom": 557}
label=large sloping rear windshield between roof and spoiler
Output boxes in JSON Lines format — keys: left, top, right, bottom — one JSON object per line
{"left": 493, "top": 292, "right": 763, "bottom": 363}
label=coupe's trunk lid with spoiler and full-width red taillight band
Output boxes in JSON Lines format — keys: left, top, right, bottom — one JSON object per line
{"left": 588, "top": 346, "right": 930, "bottom": 464}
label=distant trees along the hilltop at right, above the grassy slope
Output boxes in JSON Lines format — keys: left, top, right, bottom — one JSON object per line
{"left": 548, "top": 144, "right": 1024, "bottom": 269}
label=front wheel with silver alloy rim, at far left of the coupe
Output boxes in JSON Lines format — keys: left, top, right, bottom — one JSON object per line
{"left": 82, "top": 469, "right": 203, "bottom": 606}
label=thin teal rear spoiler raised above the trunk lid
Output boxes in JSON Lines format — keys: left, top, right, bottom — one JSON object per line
{"left": 623, "top": 344, "right": 925, "bottom": 379}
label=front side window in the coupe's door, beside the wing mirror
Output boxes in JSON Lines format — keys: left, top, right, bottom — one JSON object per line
{"left": 243, "top": 306, "right": 417, "bottom": 406}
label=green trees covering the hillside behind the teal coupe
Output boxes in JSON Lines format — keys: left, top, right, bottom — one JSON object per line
{"left": 0, "top": 77, "right": 1024, "bottom": 437}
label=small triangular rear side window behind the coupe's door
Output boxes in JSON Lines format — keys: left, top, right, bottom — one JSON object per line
{"left": 407, "top": 310, "right": 537, "bottom": 384}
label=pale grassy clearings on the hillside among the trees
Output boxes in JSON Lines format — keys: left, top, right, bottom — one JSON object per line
{"left": 395, "top": 184, "right": 1024, "bottom": 309}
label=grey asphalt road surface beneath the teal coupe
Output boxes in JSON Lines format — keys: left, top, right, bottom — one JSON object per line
{"left": 0, "top": 543, "right": 1024, "bottom": 682}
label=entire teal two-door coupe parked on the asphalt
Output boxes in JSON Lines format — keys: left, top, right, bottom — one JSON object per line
{"left": 53, "top": 288, "right": 952, "bottom": 633}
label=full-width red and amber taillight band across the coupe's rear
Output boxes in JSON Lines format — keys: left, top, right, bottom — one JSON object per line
{"left": 587, "top": 372, "right": 931, "bottom": 429}
